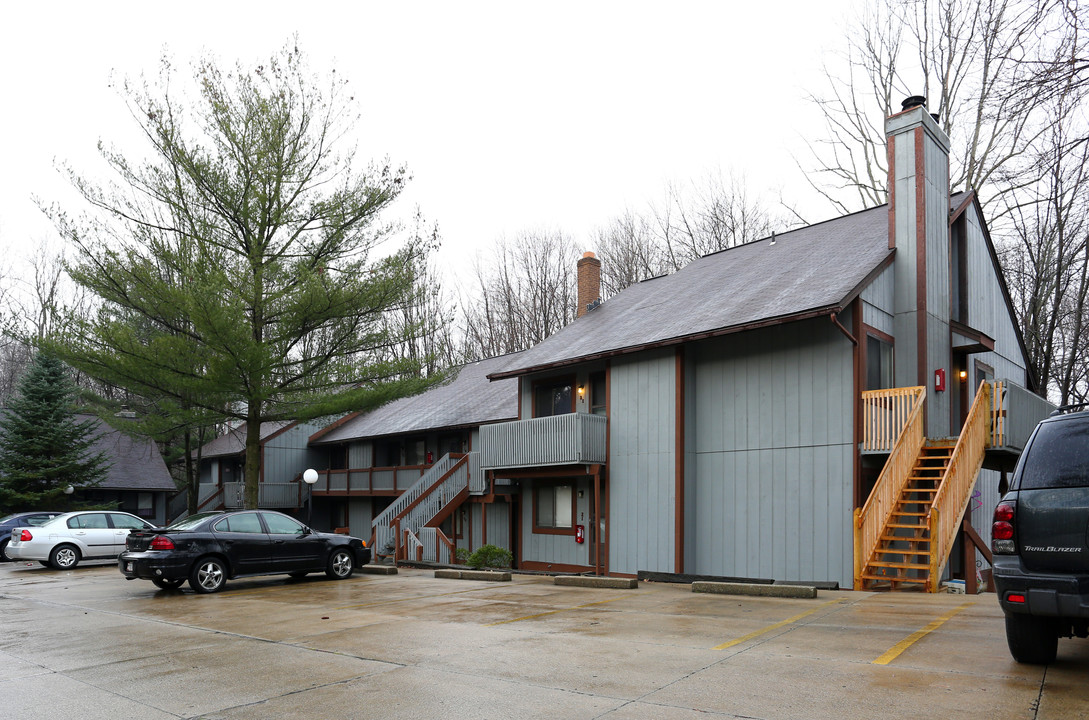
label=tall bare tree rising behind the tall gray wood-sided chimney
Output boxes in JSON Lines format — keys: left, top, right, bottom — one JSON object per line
{"left": 806, "top": 0, "right": 1043, "bottom": 215}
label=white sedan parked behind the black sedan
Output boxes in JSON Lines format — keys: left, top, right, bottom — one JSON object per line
{"left": 8, "top": 510, "right": 155, "bottom": 570}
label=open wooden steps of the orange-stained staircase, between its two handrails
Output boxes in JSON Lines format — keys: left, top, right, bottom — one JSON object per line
{"left": 861, "top": 439, "right": 956, "bottom": 590}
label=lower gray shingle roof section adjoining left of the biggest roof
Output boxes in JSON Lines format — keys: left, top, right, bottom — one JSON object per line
{"left": 310, "top": 353, "right": 521, "bottom": 444}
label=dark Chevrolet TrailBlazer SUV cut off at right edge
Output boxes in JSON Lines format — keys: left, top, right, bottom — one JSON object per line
{"left": 991, "top": 405, "right": 1089, "bottom": 663}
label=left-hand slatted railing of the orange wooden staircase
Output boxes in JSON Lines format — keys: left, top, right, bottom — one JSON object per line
{"left": 855, "top": 386, "right": 927, "bottom": 590}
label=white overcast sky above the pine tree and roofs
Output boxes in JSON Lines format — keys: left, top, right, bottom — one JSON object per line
{"left": 0, "top": 0, "right": 857, "bottom": 285}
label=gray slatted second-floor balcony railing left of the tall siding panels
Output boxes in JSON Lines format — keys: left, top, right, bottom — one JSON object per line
{"left": 480, "top": 413, "right": 608, "bottom": 469}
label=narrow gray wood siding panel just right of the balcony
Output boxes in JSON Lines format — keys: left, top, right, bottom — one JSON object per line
{"left": 609, "top": 349, "right": 676, "bottom": 573}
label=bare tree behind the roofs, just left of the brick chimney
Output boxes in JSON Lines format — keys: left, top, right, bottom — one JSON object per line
{"left": 461, "top": 231, "right": 578, "bottom": 359}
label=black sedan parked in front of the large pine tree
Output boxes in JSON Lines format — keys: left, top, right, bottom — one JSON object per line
{"left": 118, "top": 510, "right": 370, "bottom": 593}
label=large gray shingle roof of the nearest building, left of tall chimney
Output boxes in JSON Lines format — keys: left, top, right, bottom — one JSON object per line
{"left": 489, "top": 205, "right": 894, "bottom": 379}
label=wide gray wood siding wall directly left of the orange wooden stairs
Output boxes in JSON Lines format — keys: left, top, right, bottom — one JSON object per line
{"left": 692, "top": 317, "right": 854, "bottom": 586}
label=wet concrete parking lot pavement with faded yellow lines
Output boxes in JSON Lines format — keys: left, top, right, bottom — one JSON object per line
{"left": 0, "top": 563, "right": 1089, "bottom": 720}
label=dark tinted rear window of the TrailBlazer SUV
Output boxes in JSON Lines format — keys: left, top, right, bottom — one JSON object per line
{"left": 1018, "top": 418, "right": 1089, "bottom": 490}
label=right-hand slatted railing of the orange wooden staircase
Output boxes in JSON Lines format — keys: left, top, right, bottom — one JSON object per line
{"left": 927, "top": 380, "right": 993, "bottom": 593}
